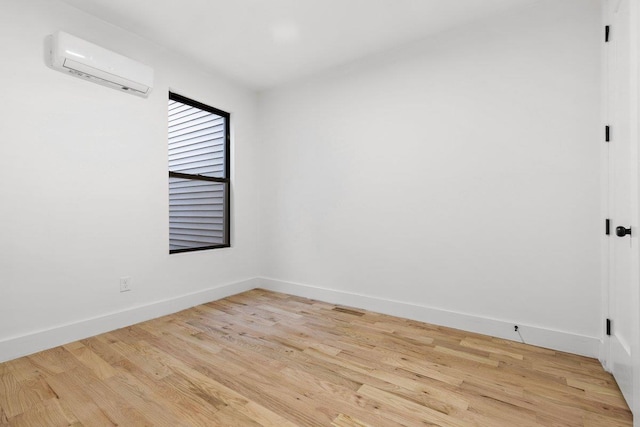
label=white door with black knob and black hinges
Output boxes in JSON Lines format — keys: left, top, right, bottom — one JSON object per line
{"left": 605, "top": 0, "right": 640, "bottom": 418}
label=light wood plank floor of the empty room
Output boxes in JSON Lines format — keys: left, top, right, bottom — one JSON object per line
{"left": 0, "top": 290, "right": 632, "bottom": 427}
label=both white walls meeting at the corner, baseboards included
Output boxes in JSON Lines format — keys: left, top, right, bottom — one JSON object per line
{"left": 0, "top": 0, "right": 602, "bottom": 361}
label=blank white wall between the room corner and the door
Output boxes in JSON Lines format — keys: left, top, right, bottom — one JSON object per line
{"left": 259, "top": 0, "right": 603, "bottom": 353}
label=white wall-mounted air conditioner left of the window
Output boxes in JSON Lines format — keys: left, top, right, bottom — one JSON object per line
{"left": 48, "top": 31, "right": 153, "bottom": 98}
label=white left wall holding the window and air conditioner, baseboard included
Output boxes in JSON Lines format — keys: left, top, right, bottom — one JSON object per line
{"left": 0, "top": 0, "right": 258, "bottom": 361}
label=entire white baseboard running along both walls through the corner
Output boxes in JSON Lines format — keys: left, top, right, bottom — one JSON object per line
{"left": 0, "top": 277, "right": 601, "bottom": 363}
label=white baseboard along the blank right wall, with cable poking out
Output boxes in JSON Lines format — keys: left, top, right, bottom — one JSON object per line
{"left": 258, "top": 278, "right": 600, "bottom": 358}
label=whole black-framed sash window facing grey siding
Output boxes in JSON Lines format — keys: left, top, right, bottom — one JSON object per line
{"left": 169, "top": 92, "right": 230, "bottom": 253}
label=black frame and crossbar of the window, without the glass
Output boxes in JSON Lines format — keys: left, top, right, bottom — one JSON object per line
{"left": 169, "top": 91, "right": 231, "bottom": 254}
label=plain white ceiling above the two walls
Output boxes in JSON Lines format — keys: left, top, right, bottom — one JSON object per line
{"left": 58, "top": 0, "right": 538, "bottom": 89}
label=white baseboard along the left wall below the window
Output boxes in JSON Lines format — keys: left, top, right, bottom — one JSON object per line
{"left": 0, "top": 278, "right": 261, "bottom": 362}
